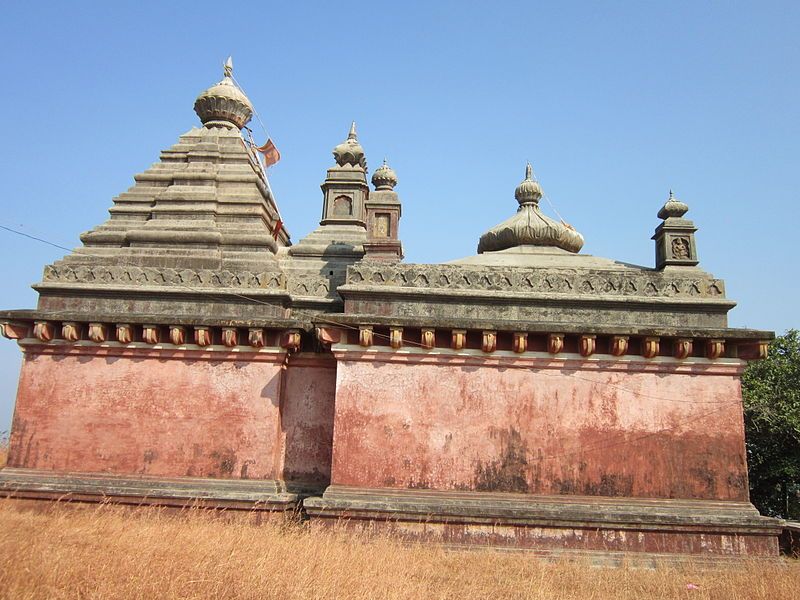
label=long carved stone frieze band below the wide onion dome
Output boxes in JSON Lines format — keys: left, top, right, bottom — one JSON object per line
{"left": 347, "top": 263, "right": 725, "bottom": 298}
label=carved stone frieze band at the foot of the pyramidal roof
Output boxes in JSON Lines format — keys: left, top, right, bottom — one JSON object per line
{"left": 42, "top": 265, "right": 286, "bottom": 289}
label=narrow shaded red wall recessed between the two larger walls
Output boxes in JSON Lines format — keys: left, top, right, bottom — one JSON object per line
{"left": 281, "top": 354, "right": 336, "bottom": 488}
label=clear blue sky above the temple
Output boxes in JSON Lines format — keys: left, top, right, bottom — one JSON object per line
{"left": 0, "top": 1, "right": 800, "bottom": 431}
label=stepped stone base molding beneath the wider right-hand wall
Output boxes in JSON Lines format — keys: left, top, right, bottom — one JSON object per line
{"left": 303, "top": 486, "right": 781, "bottom": 559}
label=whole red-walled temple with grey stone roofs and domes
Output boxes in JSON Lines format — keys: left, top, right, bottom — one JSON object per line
{"left": 0, "top": 62, "right": 779, "bottom": 558}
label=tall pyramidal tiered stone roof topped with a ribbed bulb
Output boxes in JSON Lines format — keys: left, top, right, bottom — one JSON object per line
{"left": 37, "top": 59, "right": 290, "bottom": 318}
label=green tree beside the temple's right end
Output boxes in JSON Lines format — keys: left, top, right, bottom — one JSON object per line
{"left": 742, "top": 329, "right": 800, "bottom": 520}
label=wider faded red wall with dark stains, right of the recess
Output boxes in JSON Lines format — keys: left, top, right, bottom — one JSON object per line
{"left": 332, "top": 352, "right": 748, "bottom": 501}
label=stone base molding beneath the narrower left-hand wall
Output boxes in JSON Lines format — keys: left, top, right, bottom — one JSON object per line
{"left": 0, "top": 467, "right": 302, "bottom": 512}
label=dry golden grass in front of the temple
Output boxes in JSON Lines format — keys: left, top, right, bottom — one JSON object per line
{"left": 0, "top": 500, "right": 800, "bottom": 600}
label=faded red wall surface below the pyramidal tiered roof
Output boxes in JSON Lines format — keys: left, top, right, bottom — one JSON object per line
{"left": 8, "top": 347, "right": 282, "bottom": 479}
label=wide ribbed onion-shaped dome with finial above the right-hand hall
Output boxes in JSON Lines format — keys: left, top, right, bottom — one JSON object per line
{"left": 478, "top": 164, "right": 583, "bottom": 254}
